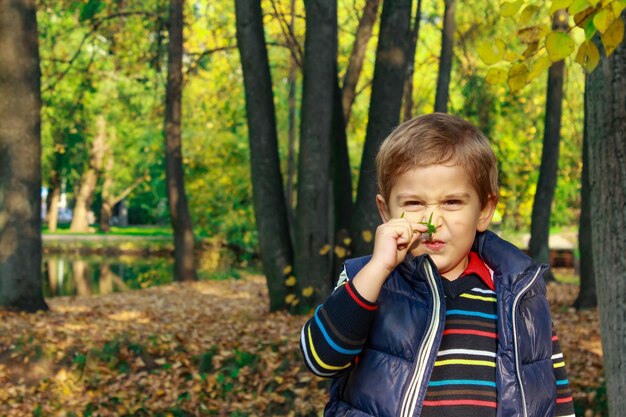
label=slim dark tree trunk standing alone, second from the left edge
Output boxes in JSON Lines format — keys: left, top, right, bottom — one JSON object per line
{"left": 164, "top": 0, "right": 197, "bottom": 281}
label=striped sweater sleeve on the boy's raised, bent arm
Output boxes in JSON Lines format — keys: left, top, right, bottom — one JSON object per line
{"left": 300, "top": 268, "right": 378, "bottom": 377}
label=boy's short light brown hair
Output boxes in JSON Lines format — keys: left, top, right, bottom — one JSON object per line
{"left": 376, "top": 113, "right": 498, "bottom": 207}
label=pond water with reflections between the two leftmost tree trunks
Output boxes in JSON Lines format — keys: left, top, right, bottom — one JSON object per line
{"left": 42, "top": 255, "right": 173, "bottom": 297}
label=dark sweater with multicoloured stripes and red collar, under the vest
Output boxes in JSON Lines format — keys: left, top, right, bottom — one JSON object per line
{"left": 300, "top": 254, "right": 574, "bottom": 417}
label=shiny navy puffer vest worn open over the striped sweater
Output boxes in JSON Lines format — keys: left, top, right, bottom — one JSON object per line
{"left": 324, "top": 232, "right": 556, "bottom": 417}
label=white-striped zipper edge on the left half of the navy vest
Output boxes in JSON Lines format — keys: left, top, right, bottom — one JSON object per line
{"left": 400, "top": 261, "right": 441, "bottom": 417}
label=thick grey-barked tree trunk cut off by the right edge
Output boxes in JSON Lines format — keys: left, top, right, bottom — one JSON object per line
{"left": 585, "top": 13, "right": 626, "bottom": 417}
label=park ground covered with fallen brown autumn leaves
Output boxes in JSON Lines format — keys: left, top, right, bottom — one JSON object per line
{"left": 0, "top": 274, "right": 606, "bottom": 417}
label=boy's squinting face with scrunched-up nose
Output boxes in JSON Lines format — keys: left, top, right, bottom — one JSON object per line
{"left": 376, "top": 165, "right": 495, "bottom": 280}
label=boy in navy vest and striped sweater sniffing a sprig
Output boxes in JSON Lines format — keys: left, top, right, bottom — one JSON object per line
{"left": 300, "top": 113, "right": 574, "bottom": 417}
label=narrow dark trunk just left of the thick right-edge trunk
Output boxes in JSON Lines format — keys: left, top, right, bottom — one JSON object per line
{"left": 574, "top": 98, "right": 598, "bottom": 310}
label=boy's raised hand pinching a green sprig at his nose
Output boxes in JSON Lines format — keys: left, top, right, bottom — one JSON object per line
{"left": 370, "top": 218, "right": 428, "bottom": 273}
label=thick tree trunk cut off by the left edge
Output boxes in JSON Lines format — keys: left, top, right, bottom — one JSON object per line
{"left": 0, "top": 0, "right": 48, "bottom": 311}
